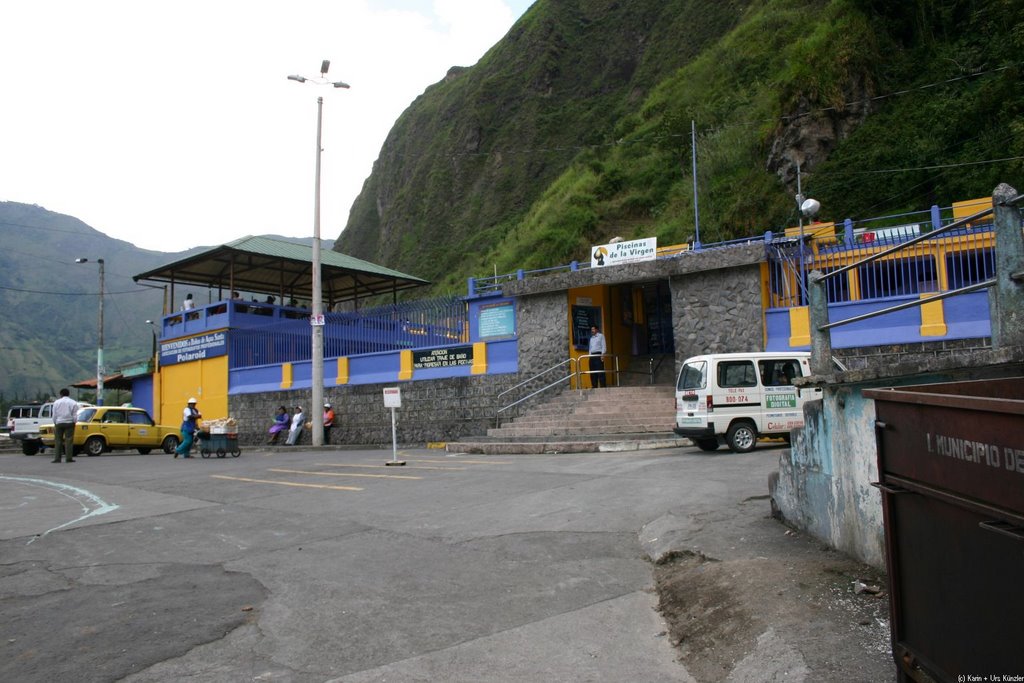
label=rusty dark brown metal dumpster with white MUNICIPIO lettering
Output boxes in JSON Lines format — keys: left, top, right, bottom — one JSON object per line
{"left": 864, "top": 378, "right": 1024, "bottom": 681}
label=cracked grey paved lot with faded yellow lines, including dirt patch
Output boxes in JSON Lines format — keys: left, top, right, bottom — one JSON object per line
{"left": 0, "top": 449, "right": 894, "bottom": 683}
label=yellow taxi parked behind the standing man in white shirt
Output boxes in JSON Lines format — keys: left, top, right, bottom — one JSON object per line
{"left": 39, "top": 405, "right": 180, "bottom": 456}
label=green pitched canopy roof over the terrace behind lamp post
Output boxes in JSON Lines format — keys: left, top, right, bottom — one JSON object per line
{"left": 134, "top": 237, "right": 430, "bottom": 305}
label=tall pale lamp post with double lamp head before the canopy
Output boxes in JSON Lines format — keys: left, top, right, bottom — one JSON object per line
{"left": 288, "top": 59, "right": 349, "bottom": 445}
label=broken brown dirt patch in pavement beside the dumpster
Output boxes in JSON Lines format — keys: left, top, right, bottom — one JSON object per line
{"left": 654, "top": 520, "right": 895, "bottom": 683}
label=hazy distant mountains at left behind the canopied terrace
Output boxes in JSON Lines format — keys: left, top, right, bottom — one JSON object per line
{"left": 0, "top": 202, "right": 330, "bottom": 404}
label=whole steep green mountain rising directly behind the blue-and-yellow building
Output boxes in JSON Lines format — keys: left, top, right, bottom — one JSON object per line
{"left": 335, "top": 0, "right": 1024, "bottom": 293}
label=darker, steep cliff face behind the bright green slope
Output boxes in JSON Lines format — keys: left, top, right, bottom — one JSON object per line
{"left": 336, "top": 0, "right": 749, "bottom": 286}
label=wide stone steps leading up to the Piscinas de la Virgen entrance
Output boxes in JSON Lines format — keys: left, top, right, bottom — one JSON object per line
{"left": 446, "top": 385, "right": 690, "bottom": 455}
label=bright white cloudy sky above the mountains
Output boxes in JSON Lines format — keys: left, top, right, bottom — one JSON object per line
{"left": 0, "top": 0, "right": 534, "bottom": 252}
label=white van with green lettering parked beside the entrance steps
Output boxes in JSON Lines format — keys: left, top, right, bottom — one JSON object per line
{"left": 675, "top": 351, "right": 821, "bottom": 453}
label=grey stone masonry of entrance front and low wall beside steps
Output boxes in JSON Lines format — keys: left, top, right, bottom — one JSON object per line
{"left": 228, "top": 243, "right": 764, "bottom": 446}
